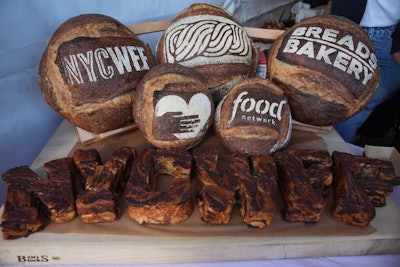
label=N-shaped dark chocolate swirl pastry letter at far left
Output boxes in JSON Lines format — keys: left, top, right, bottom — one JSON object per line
{"left": 1, "top": 158, "right": 77, "bottom": 240}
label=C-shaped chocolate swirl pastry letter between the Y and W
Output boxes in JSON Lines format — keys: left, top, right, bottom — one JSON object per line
{"left": 125, "top": 148, "right": 193, "bottom": 224}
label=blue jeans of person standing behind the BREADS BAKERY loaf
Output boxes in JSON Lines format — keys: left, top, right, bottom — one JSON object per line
{"left": 334, "top": 25, "right": 400, "bottom": 143}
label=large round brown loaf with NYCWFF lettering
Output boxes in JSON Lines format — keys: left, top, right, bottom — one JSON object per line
{"left": 39, "top": 14, "right": 155, "bottom": 134}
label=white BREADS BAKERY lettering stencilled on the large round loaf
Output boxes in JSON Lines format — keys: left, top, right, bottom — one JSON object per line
{"left": 277, "top": 26, "right": 377, "bottom": 98}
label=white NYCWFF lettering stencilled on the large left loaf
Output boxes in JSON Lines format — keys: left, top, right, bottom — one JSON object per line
{"left": 57, "top": 38, "right": 150, "bottom": 85}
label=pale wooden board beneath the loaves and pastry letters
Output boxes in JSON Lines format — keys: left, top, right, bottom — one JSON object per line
{"left": 0, "top": 121, "right": 400, "bottom": 265}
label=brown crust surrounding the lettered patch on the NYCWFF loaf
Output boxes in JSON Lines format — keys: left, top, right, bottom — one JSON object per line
{"left": 39, "top": 14, "right": 155, "bottom": 134}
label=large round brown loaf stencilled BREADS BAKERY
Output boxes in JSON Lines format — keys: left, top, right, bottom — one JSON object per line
{"left": 268, "top": 16, "right": 379, "bottom": 126}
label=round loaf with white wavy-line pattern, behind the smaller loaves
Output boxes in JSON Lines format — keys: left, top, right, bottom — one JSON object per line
{"left": 156, "top": 3, "right": 257, "bottom": 103}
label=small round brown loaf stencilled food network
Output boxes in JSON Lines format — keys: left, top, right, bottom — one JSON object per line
{"left": 215, "top": 78, "right": 292, "bottom": 155}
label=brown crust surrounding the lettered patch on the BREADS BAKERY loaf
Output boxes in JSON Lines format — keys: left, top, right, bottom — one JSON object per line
{"left": 267, "top": 16, "right": 379, "bottom": 126}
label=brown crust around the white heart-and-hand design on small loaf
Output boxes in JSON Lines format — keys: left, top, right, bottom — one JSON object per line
{"left": 133, "top": 63, "right": 214, "bottom": 149}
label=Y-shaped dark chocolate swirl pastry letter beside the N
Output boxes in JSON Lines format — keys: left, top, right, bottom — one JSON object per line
{"left": 74, "top": 147, "right": 136, "bottom": 223}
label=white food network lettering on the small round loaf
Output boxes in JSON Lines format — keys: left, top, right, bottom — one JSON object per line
{"left": 228, "top": 91, "right": 287, "bottom": 125}
